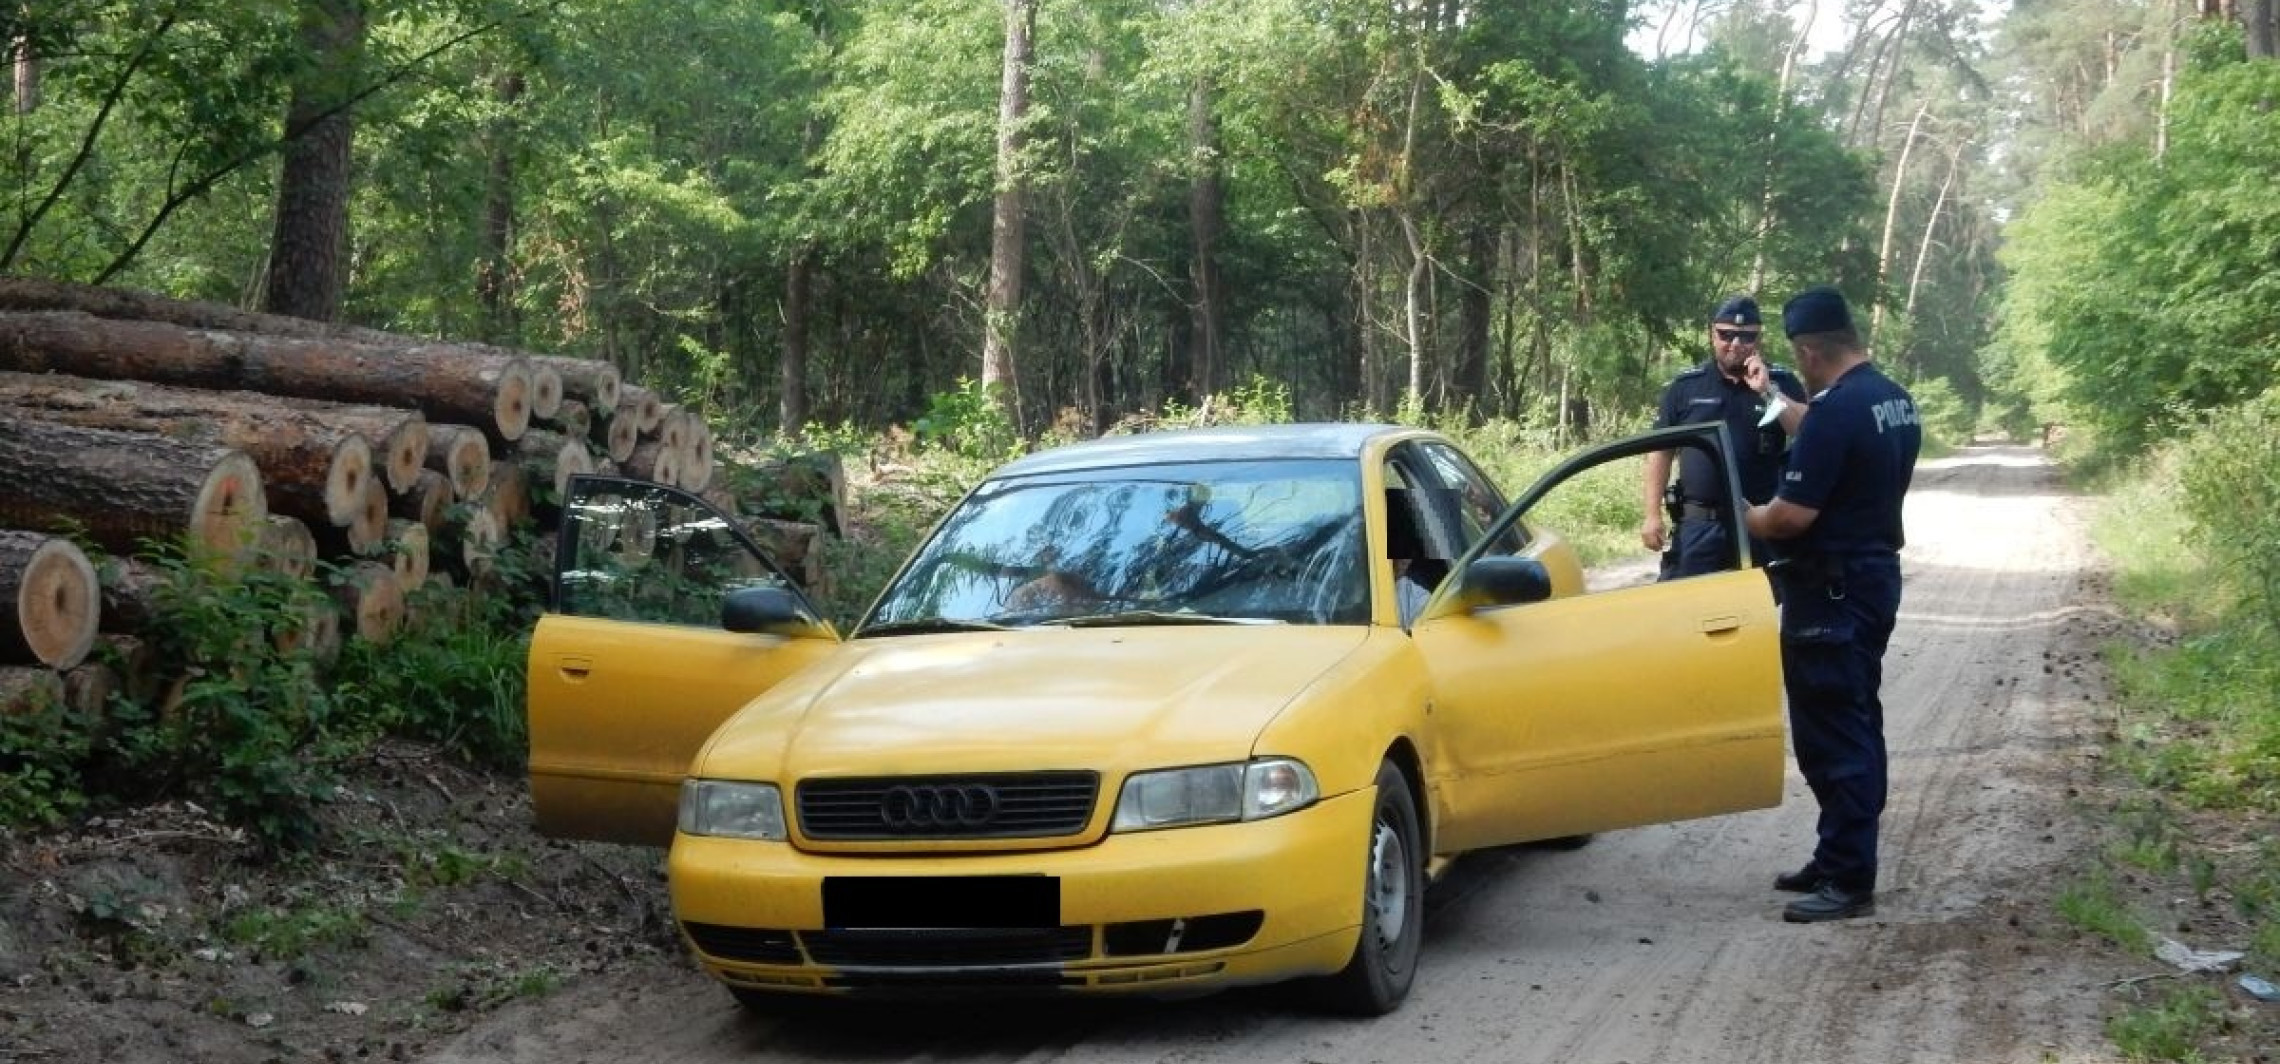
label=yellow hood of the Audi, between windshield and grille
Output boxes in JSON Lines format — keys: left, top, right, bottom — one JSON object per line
{"left": 698, "top": 624, "right": 1368, "bottom": 781}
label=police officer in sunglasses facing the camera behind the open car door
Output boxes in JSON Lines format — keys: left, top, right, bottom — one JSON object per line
{"left": 1639, "top": 296, "right": 1806, "bottom": 579}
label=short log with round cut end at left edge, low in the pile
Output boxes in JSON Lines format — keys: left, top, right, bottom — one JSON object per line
{"left": 0, "top": 529, "right": 103, "bottom": 670}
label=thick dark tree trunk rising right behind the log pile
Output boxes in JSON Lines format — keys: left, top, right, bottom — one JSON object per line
{"left": 262, "top": 0, "right": 365, "bottom": 321}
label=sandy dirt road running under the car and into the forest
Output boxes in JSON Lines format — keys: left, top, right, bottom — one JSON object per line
{"left": 426, "top": 447, "right": 2116, "bottom": 1064}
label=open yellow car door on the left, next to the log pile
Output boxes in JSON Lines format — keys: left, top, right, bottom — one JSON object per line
{"left": 527, "top": 476, "right": 839, "bottom": 845}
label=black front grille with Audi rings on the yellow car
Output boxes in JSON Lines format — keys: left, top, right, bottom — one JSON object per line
{"left": 796, "top": 772, "right": 1101, "bottom": 841}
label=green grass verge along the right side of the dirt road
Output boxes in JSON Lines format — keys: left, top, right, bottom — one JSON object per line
{"left": 2088, "top": 428, "right": 2280, "bottom": 1062}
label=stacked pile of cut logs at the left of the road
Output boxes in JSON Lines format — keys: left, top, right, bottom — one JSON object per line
{"left": 0, "top": 278, "right": 837, "bottom": 711}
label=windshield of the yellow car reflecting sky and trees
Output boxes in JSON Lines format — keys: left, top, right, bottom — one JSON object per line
{"left": 864, "top": 460, "right": 1368, "bottom": 631}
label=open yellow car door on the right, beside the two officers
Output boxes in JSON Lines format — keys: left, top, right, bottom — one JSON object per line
{"left": 1414, "top": 424, "right": 1783, "bottom": 852}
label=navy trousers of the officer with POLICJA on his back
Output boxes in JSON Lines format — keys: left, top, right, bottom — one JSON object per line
{"left": 1781, "top": 554, "right": 1899, "bottom": 891}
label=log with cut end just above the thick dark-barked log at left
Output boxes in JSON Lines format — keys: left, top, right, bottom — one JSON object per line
{"left": 0, "top": 371, "right": 373, "bottom": 524}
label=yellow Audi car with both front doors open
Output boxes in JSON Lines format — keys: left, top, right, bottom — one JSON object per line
{"left": 529, "top": 424, "right": 1783, "bottom": 1014}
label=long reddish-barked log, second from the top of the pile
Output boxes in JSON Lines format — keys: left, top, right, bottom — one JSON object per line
{"left": 0, "top": 312, "right": 531, "bottom": 442}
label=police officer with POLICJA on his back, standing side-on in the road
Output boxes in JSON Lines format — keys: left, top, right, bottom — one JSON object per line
{"left": 1744, "top": 287, "right": 1922, "bottom": 923}
